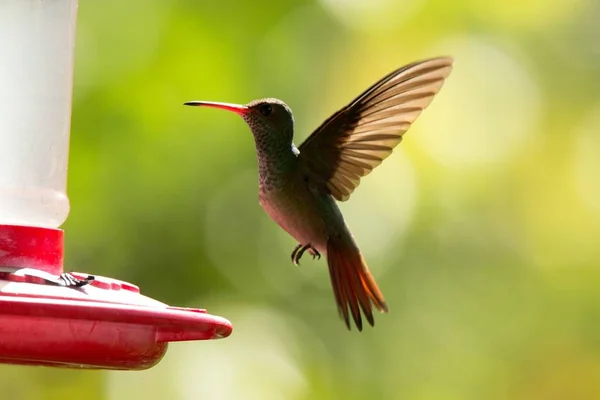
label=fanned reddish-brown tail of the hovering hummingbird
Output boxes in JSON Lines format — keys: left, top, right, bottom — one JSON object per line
{"left": 327, "top": 238, "right": 388, "bottom": 331}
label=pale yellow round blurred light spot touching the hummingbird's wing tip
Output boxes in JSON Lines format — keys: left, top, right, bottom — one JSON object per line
{"left": 417, "top": 36, "right": 540, "bottom": 166}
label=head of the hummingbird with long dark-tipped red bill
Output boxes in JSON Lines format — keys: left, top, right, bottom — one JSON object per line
{"left": 184, "top": 98, "right": 294, "bottom": 147}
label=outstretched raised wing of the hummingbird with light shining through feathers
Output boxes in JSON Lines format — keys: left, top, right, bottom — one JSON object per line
{"left": 298, "top": 57, "right": 453, "bottom": 201}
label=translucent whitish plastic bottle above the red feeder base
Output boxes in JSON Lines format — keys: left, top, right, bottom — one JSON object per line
{"left": 0, "top": 0, "right": 77, "bottom": 228}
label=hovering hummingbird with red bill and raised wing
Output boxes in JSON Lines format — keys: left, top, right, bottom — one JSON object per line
{"left": 184, "top": 57, "right": 453, "bottom": 331}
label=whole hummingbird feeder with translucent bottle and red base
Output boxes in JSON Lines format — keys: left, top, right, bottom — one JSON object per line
{"left": 0, "top": 0, "right": 232, "bottom": 370}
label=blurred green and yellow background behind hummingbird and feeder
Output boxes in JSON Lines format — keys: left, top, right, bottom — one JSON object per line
{"left": 5, "top": 0, "right": 600, "bottom": 400}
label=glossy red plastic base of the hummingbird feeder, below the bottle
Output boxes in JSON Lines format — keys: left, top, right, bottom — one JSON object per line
{"left": 0, "top": 225, "right": 233, "bottom": 370}
